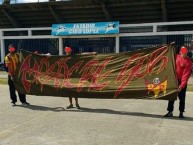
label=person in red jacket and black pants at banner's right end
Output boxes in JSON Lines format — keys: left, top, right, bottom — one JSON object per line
{"left": 164, "top": 46, "right": 192, "bottom": 118}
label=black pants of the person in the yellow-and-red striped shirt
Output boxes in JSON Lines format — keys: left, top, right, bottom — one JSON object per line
{"left": 8, "top": 76, "right": 26, "bottom": 103}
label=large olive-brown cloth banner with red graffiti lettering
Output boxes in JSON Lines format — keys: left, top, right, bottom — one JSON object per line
{"left": 15, "top": 45, "right": 177, "bottom": 100}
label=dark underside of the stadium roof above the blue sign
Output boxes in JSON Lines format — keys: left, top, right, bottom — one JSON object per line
{"left": 0, "top": 0, "right": 193, "bottom": 28}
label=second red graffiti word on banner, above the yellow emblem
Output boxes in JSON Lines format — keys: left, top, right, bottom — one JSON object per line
{"left": 114, "top": 47, "right": 168, "bottom": 98}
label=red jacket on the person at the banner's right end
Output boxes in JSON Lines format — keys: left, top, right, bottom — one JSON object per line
{"left": 176, "top": 54, "right": 192, "bottom": 88}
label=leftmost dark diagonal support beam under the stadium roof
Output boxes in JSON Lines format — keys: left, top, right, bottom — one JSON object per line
{"left": 1, "top": 8, "right": 22, "bottom": 28}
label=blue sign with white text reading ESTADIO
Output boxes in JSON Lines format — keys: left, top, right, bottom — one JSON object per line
{"left": 52, "top": 21, "right": 119, "bottom": 36}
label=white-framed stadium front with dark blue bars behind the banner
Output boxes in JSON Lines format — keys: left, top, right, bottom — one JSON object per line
{"left": 0, "top": 21, "right": 193, "bottom": 61}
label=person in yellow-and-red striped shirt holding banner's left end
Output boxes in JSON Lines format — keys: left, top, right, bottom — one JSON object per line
{"left": 5, "top": 44, "right": 29, "bottom": 106}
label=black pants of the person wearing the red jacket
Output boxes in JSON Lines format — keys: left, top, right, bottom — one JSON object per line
{"left": 167, "top": 80, "right": 187, "bottom": 112}
